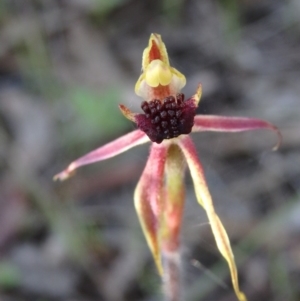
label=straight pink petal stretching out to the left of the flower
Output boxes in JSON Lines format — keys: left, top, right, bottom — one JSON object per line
{"left": 54, "top": 130, "right": 149, "bottom": 181}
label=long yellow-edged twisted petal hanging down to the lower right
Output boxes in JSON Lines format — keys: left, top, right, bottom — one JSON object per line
{"left": 178, "top": 136, "right": 247, "bottom": 301}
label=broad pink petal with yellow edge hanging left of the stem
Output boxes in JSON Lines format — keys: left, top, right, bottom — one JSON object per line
{"left": 134, "top": 143, "right": 168, "bottom": 274}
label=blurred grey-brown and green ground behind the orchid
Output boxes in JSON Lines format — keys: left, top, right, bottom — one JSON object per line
{"left": 0, "top": 0, "right": 300, "bottom": 301}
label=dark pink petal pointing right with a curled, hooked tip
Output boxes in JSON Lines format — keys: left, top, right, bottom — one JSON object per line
{"left": 193, "top": 115, "right": 282, "bottom": 150}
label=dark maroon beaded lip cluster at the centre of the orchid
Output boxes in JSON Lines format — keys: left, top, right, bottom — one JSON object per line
{"left": 137, "top": 93, "right": 196, "bottom": 143}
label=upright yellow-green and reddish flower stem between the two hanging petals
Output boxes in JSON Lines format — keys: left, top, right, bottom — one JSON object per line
{"left": 160, "top": 145, "right": 185, "bottom": 301}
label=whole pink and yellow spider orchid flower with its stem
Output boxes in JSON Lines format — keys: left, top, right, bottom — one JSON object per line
{"left": 54, "top": 34, "right": 281, "bottom": 301}
